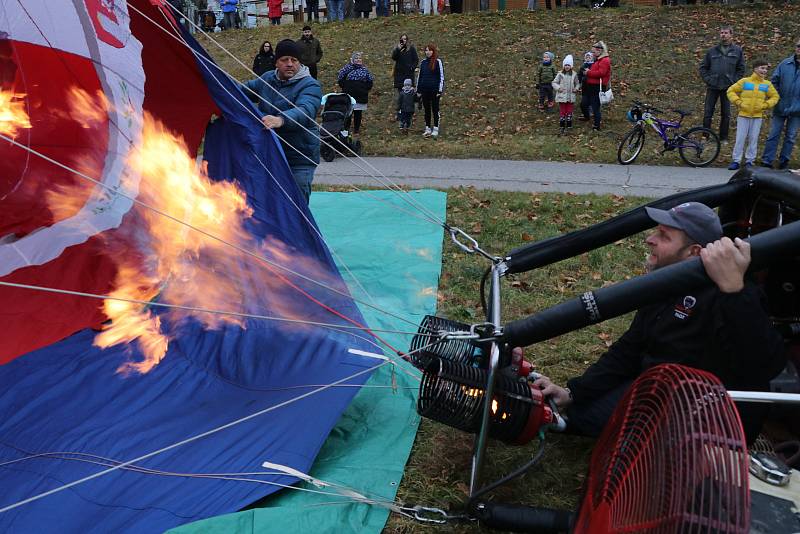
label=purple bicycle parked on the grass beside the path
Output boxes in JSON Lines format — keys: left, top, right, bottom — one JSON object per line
{"left": 617, "top": 100, "right": 719, "bottom": 167}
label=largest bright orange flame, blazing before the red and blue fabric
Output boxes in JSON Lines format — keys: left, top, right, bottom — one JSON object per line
{"left": 88, "top": 114, "right": 251, "bottom": 373}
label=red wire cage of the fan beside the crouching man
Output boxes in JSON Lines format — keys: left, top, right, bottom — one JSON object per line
{"left": 575, "top": 365, "right": 750, "bottom": 534}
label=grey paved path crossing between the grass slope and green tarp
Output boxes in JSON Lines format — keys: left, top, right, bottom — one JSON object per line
{"left": 314, "top": 157, "right": 734, "bottom": 197}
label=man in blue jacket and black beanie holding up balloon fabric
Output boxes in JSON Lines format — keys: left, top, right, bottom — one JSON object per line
{"left": 244, "top": 39, "right": 322, "bottom": 201}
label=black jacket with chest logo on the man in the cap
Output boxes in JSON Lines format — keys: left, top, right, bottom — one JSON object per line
{"left": 567, "top": 282, "right": 786, "bottom": 402}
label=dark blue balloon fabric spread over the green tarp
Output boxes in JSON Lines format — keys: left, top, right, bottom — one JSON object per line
{"left": 0, "top": 3, "right": 383, "bottom": 533}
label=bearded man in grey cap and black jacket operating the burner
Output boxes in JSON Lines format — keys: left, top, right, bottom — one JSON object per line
{"left": 535, "top": 202, "right": 786, "bottom": 442}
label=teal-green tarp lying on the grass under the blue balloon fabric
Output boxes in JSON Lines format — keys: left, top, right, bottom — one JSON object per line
{"left": 171, "top": 191, "right": 446, "bottom": 534}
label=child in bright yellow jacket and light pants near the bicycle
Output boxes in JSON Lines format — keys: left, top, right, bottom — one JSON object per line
{"left": 728, "top": 60, "right": 780, "bottom": 171}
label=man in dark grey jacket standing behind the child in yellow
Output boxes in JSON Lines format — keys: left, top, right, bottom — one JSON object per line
{"left": 700, "top": 26, "right": 745, "bottom": 141}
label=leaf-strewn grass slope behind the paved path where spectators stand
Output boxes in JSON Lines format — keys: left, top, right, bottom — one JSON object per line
{"left": 201, "top": 4, "right": 800, "bottom": 165}
